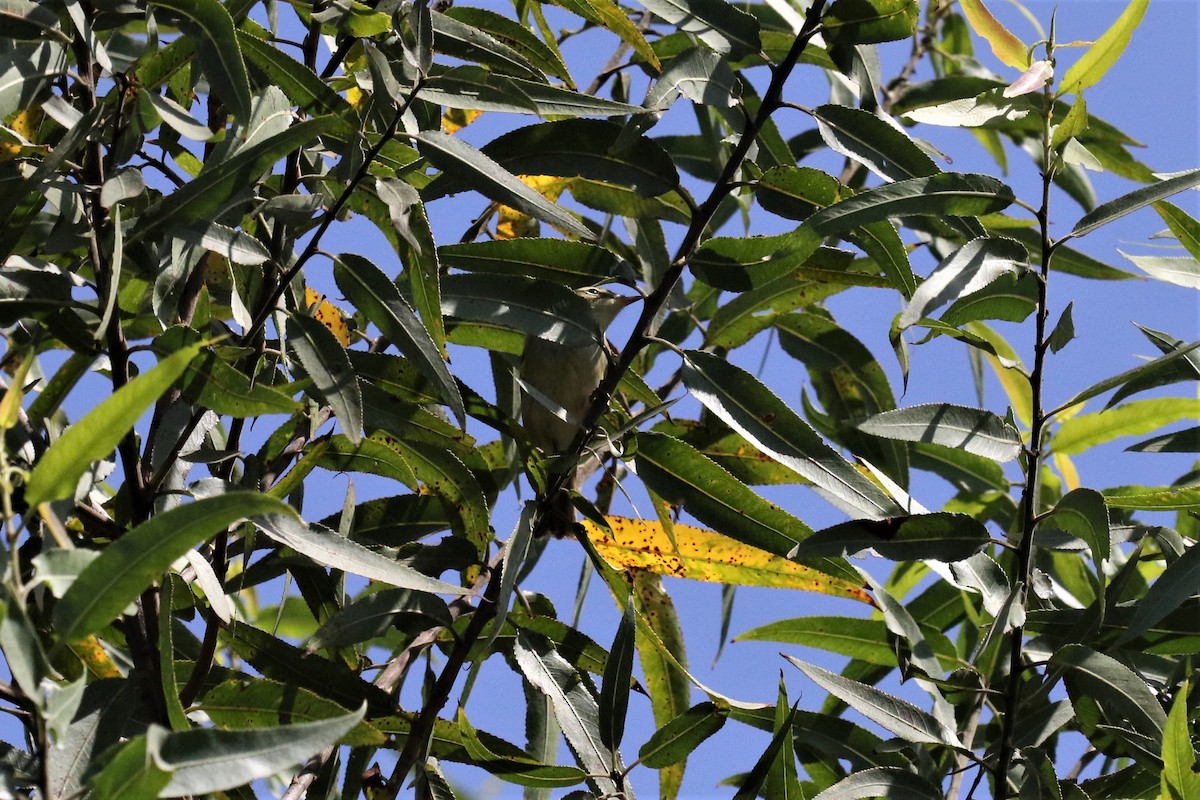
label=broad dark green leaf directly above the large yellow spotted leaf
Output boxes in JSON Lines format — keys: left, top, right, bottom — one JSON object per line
{"left": 636, "top": 433, "right": 860, "bottom": 582}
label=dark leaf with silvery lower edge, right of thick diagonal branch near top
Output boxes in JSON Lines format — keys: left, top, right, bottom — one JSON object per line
{"left": 812, "top": 103, "right": 940, "bottom": 181}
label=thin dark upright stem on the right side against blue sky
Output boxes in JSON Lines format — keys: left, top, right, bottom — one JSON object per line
{"left": 995, "top": 73, "right": 1056, "bottom": 798}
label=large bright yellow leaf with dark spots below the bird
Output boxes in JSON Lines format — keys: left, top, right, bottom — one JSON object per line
{"left": 583, "top": 517, "right": 871, "bottom": 603}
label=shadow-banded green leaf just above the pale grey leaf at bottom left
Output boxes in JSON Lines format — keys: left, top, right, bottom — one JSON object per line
{"left": 199, "top": 674, "right": 384, "bottom": 746}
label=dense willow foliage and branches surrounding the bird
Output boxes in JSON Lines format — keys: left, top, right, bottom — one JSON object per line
{"left": 0, "top": 0, "right": 1200, "bottom": 800}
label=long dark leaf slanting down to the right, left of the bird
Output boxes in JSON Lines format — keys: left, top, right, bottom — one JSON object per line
{"left": 334, "top": 253, "right": 467, "bottom": 425}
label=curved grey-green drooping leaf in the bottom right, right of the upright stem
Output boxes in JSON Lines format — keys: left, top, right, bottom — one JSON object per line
{"left": 1050, "top": 644, "right": 1166, "bottom": 753}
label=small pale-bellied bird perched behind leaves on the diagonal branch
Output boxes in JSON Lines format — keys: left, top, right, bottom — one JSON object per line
{"left": 518, "top": 287, "right": 638, "bottom": 539}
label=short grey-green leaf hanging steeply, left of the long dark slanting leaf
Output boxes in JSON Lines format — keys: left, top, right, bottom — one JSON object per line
{"left": 287, "top": 313, "right": 362, "bottom": 445}
